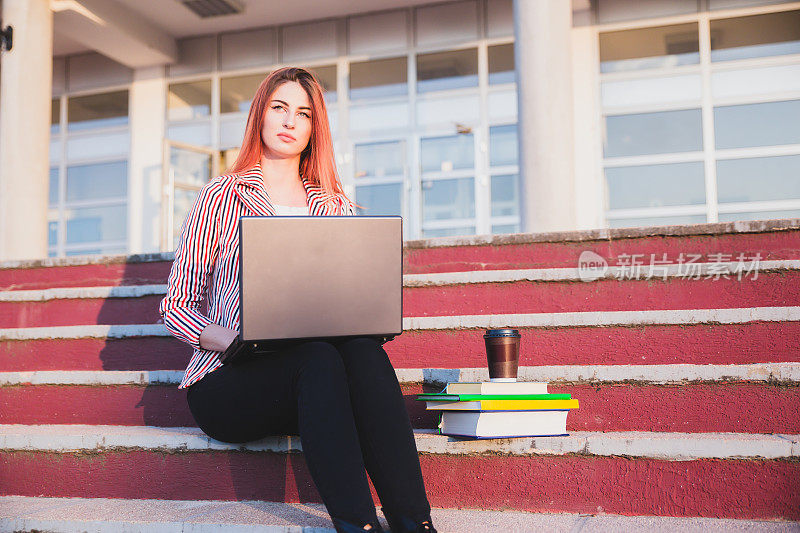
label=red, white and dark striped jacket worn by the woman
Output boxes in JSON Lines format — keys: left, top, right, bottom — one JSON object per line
{"left": 158, "top": 163, "right": 355, "bottom": 389}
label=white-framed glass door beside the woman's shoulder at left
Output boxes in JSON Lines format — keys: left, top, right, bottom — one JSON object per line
{"left": 161, "top": 139, "right": 220, "bottom": 252}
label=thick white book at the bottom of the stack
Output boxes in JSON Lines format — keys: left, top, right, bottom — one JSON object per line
{"left": 439, "top": 411, "right": 569, "bottom": 438}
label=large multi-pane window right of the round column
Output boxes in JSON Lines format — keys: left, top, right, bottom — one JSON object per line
{"left": 599, "top": 9, "right": 800, "bottom": 227}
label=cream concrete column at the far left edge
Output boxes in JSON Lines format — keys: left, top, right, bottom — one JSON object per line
{"left": 0, "top": 0, "right": 53, "bottom": 261}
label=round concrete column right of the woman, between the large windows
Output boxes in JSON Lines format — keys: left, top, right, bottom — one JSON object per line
{"left": 514, "top": 0, "right": 576, "bottom": 232}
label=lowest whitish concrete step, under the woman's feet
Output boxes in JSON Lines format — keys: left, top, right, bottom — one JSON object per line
{"left": 0, "top": 496, "right": 800, "bottom": 533}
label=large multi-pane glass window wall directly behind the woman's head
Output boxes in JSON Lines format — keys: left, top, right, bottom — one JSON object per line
{"left": 161, "top": 10, "right": 521, "bottom": 241}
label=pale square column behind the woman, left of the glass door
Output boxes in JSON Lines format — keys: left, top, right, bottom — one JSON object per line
{"left": 128, "top": 66, "right": 167, "bottom": 254}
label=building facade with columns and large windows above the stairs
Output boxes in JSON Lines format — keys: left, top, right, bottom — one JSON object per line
{"left": 0, "top": 0, "right": 800, "bottom": 259}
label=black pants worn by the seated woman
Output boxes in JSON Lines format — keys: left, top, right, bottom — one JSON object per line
{"left": 187, "top": 337, "right": 430, "bottom": 527}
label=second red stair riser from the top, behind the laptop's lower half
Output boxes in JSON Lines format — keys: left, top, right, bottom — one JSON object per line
{"left": 0, "top": 271, "right": 800, "bottom": 328}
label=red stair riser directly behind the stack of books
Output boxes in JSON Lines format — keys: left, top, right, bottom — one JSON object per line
{"left": 0, "top": 382, "right": 800, "bottom": 434}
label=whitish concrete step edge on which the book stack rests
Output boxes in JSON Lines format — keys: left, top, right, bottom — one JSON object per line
{"left": 0, "top": 424, "right": 800, "bottom": 461}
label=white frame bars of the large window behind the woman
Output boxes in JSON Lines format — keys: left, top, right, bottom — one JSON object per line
{"left": 163, "top": 0, "right": 524, "bottom": 240}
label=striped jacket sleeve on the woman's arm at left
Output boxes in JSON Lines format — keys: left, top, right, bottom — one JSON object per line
{"left": 158, "top": 184, "right": 220, "bottom": 349}
